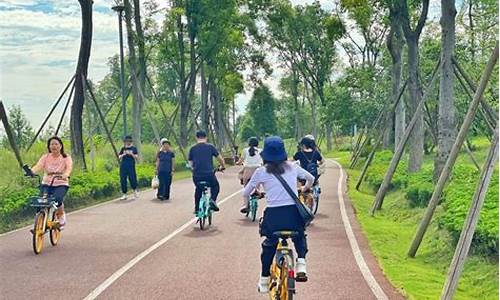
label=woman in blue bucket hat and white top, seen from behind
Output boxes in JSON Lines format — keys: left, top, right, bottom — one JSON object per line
{"left": 243, "top": 136, "right": 314, "bottom": 293}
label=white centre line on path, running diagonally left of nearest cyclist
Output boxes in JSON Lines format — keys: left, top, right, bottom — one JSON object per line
{"left": 84, "top": 190, "right": 241, "bottom": 300}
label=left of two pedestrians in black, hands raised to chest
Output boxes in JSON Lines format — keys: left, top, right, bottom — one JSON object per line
{"left": 118, "top": 135, "right": 138, "bottom": 200}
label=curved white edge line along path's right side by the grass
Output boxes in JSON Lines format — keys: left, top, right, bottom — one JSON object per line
{"left": 329, "top": 159, "right": 389, "bottom": 300}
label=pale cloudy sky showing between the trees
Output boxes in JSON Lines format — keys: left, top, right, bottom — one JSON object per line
{"left": 0, "top": 0, "right": 438, "bottom": 128}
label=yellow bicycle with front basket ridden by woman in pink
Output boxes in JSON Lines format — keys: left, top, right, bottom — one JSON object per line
{"left": 29, "top": 175, "right": 61, "bottom": 254}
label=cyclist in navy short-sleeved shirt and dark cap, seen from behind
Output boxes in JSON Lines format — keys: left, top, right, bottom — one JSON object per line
{"left": 188, "top": 130, "right": 225, "bottom": 214}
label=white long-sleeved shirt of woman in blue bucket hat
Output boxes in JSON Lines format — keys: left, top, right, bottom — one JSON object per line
{"left": 243, "top": 162, "right": 314, "bottom": 207}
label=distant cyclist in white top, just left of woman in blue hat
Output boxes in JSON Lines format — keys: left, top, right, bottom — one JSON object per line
{"left": 238, "top": 137, "right": 262, "bottom": 214}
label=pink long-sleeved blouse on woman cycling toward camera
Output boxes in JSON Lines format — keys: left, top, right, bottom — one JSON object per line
{"left": 38, "top": 153, "right": 73, "bottom": 186}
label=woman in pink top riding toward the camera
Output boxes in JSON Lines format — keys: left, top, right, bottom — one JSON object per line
{"left": 31, "top": 136, "right": 73, "bottom": 228}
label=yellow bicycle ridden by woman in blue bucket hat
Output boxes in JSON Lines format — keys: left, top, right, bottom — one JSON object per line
{"left": 269, "top": 231, "right": 298, "bottom": 300}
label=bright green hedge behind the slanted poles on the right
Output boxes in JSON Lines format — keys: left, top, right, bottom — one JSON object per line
{"left": 365, "top": 148, "right": 499, "bottom": 255}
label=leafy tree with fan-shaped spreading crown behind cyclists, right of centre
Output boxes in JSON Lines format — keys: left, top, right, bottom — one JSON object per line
{"left": 266, "top": 0, "right": 345, "bottom": 150}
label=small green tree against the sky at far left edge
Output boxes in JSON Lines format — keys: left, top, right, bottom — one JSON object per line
{"left": 2, "top": 105, "right": 35, "bottom": 148}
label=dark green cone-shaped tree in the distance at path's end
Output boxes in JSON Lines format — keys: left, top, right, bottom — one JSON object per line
{"left": 247, "top": 85, "right": 276, "bottom": 137}
